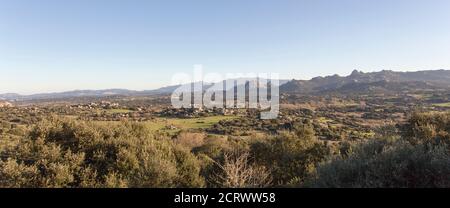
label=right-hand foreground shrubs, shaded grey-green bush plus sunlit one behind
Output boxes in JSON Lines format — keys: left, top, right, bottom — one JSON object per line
{"left": 306, "top": 113, "right": 450, "bottom": 187}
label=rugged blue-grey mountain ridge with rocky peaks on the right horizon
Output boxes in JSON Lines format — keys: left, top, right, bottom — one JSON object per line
{"left": 280, "top": 70, "right": 450, "bottom": 93}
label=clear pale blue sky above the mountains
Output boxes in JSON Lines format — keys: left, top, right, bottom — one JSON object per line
{"left": 0, "top": 0, "right": 450, "bottom": 94}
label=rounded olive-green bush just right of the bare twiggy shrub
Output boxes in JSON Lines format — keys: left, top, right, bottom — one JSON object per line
{"left": 251, "top": 124, "right": 331, "bottom": 185}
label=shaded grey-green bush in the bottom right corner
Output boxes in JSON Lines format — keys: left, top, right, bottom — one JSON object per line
{"left": 306, "top": 141, "right": 450, "bottom": 188}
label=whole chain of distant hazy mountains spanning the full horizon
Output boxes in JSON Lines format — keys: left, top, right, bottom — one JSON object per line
{"left": 0, "top": 70, "right": 450, "bottom": 101}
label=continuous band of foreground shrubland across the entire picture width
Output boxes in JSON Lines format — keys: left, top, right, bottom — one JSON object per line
{"left": 0, "top": 113, "right": 450, "bottom": 187}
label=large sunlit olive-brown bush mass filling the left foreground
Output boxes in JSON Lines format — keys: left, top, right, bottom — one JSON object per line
{"left": 0, "top": 118, "right": 204, "bottom": 187}
